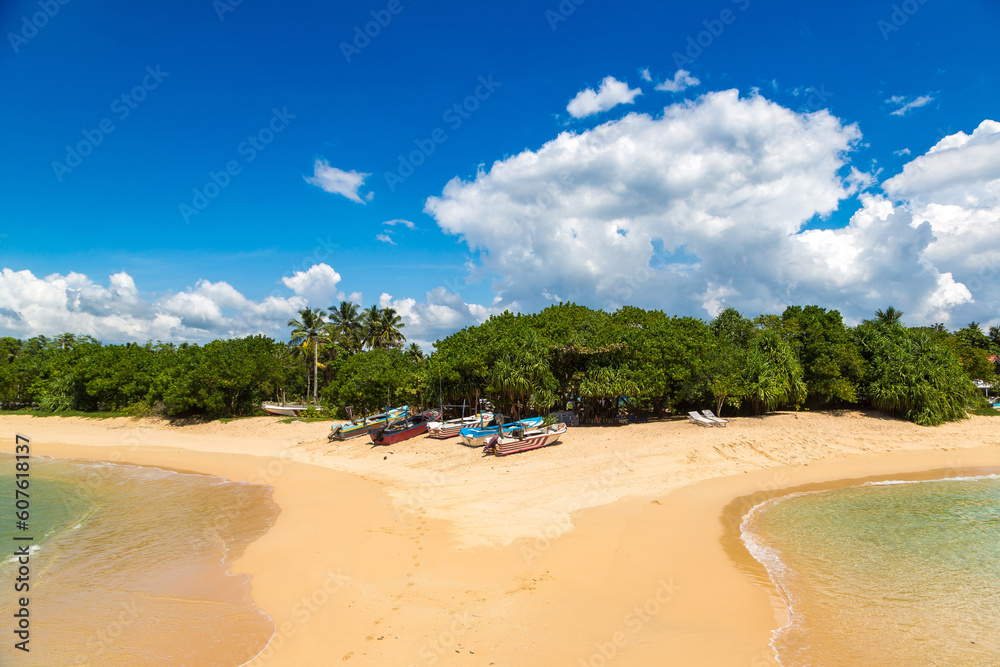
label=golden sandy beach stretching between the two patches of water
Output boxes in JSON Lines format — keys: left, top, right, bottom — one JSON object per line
{"left": 0, "top": 411, "right": 1000, "bottom": 667}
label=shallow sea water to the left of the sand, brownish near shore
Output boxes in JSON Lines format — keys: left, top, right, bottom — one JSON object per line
{"left": 0, "top": 454, "right": 278, "bottom": 665}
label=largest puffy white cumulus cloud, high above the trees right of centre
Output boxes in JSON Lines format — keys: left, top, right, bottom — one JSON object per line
{"left": 425, "top": 90, "right": 861, "bottom": 313}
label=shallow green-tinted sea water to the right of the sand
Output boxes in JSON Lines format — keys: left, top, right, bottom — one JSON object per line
{"left": 742, "top": 475, "right": 1000, "bottom": 667}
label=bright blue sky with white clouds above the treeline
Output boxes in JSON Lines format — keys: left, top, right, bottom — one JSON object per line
{"left": 0, "top": 0, "right": 1000, "bottom": 343}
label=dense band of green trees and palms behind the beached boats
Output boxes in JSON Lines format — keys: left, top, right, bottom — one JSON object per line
{"left": 0, "top": 302, "right": 1000, "bottom": 425}
